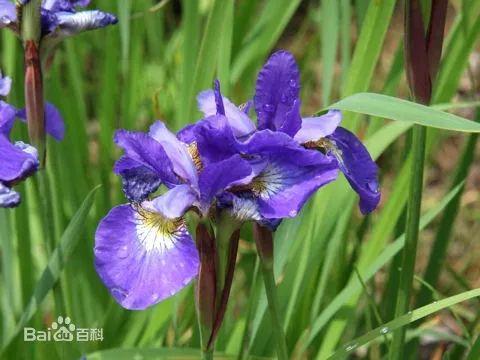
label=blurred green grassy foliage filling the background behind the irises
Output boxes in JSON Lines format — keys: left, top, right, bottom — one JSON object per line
{"left": 0, "top": 0, "right": 480, "bottom": 359}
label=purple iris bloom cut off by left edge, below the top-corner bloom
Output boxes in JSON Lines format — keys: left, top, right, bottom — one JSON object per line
{"left": 0, "top": 73, "right": 64, "bottom": 208}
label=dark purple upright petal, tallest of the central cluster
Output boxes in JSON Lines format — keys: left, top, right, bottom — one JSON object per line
{"left": 254, "top": 51, "right": 302, "bottom": 136}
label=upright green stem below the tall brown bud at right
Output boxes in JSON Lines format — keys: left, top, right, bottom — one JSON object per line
{"left": 389, "top": 125, "right": 426, "bottom": 360}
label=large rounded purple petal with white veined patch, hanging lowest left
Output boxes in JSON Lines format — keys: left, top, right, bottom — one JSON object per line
{"left": 94, "top": 205, "right": 199, "bottom": 310}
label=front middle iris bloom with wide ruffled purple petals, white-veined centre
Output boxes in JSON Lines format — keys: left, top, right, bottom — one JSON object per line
{"left": 179, "top": 112, "right": 338, "bottom": 230}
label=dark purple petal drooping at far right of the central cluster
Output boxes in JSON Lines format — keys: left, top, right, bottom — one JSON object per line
{"left": 328, "top": 127, "right": 381, "bottom": 214}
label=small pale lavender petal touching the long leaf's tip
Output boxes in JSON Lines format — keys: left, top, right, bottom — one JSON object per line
{"left": 294, "top": 110, "right": 342, "bottom": 144}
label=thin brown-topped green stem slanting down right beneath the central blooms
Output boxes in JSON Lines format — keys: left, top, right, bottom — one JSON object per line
{"left": 254, "top": 224, "right": 288, "bottom": 360}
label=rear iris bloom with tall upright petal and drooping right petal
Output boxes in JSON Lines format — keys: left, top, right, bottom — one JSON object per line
{"left": 193, "top": 51, "right": 380, "bottom": 214}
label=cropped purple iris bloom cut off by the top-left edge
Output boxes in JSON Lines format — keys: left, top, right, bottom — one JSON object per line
{"left": 0, "top": 0, "right": 118, "bottom": 38}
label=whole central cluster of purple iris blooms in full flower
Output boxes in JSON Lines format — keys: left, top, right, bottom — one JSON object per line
{"left": 94, "top": 51, "right": 380, "bottom": 309}
